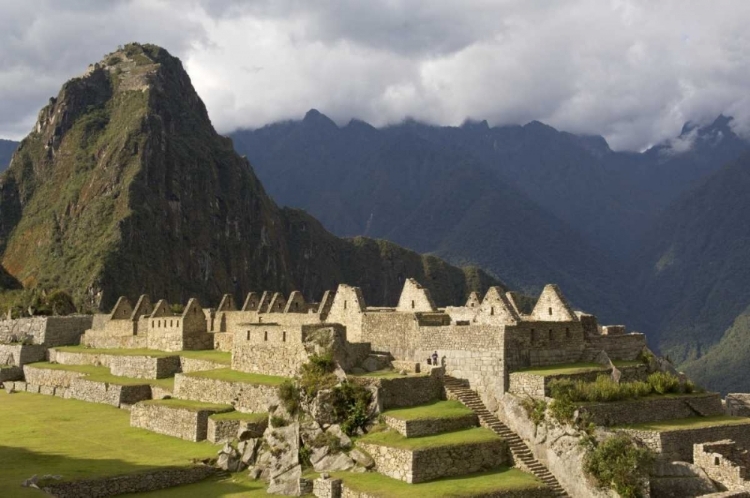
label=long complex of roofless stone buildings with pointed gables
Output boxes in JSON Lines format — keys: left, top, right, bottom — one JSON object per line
{"left": 82, "top": 279, "right": 646, "bottom": 406}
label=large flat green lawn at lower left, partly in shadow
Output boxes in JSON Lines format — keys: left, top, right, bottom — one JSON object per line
{"left": 0, "top": 391, "right": 222, "bottom": 497}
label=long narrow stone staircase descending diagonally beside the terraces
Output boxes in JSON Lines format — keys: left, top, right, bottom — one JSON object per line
{"left": 444, "top": 375, "right": 570, "bottom": 498}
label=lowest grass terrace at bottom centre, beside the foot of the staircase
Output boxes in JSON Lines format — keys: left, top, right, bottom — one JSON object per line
{"left": 333, "top": 467, "right": 544, "bottom": 498}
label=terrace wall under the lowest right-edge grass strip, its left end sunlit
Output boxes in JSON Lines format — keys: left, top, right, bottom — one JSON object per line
{"left": 623, "top": 424, "right": 750, "bottom": 462}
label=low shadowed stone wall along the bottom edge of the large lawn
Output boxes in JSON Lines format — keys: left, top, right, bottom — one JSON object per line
{"left": 43, "top": 465, "right": 217, "bottom": 498}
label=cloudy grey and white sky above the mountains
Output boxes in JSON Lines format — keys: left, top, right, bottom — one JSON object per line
{"left": 0, "top": 0, "right": 750, "bottom": 150}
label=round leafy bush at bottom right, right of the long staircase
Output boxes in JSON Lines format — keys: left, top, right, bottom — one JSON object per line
{"left": 583, "top": 434, "right": 654, "bottom": 498}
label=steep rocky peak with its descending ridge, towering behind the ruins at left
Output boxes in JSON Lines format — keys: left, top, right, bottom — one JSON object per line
{"left": 0, "top": 44, "right": 496, "bottom": 308}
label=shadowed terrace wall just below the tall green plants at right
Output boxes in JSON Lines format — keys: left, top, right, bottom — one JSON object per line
{"left": 582, "top": 393, "right": 724, "bottom": 426}
